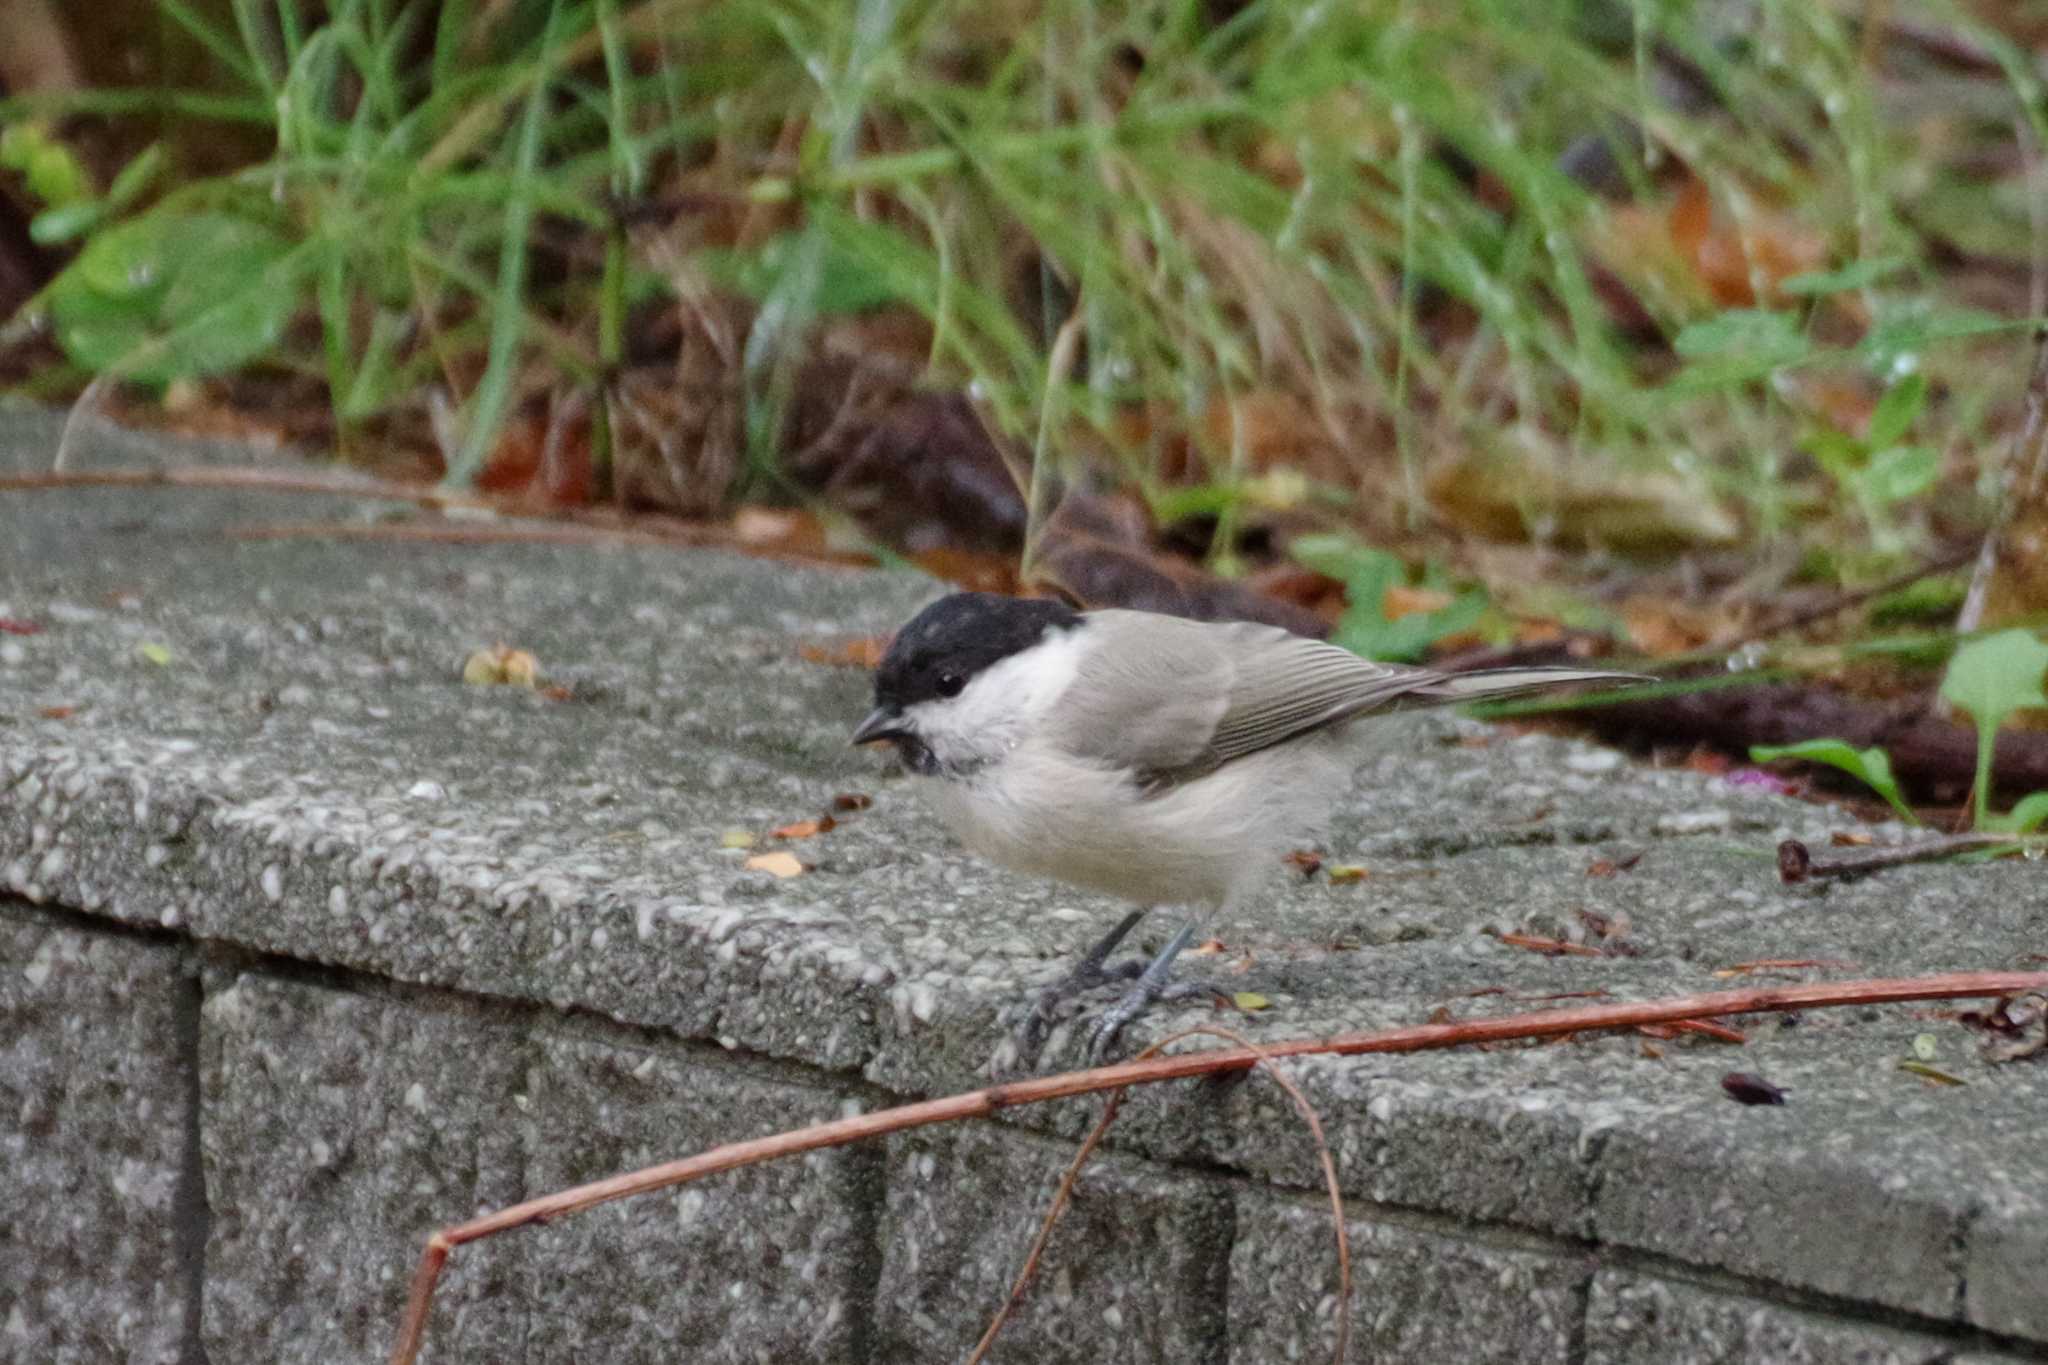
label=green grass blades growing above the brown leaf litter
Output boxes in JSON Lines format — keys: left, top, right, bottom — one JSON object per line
{"left": 0, "top": 0, "right": 2048, "bottom": 597}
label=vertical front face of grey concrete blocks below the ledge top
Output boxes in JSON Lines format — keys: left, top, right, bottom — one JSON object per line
{"left": 0, "top": 898, "right": 2044, "bottom": 1365}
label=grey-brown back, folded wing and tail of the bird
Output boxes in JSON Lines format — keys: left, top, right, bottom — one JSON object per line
{"left": 1053, "top": 610, "right": 1636, "bottom": 786}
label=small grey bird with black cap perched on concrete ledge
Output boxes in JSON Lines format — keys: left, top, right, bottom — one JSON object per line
{"left": 852, "top": 593, "right": 1640, "bottom": 1062}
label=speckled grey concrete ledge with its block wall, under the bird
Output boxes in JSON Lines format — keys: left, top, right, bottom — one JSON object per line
{"left": 0, "top": 417, "right": 2048, "bottom": 1361}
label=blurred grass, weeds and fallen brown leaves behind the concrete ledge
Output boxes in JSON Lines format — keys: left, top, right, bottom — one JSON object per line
{"left": 0, "top": 0, "right": 2048, "bottom": 657}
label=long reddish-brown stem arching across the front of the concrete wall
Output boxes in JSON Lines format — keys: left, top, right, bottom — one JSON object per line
{"left": 391, "top": 972, "right": 2048, "bottom": 1365}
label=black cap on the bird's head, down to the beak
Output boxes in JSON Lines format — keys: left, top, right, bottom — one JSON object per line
{"left": 854, "top": 593, "right": 1081, "bottom": 745}
